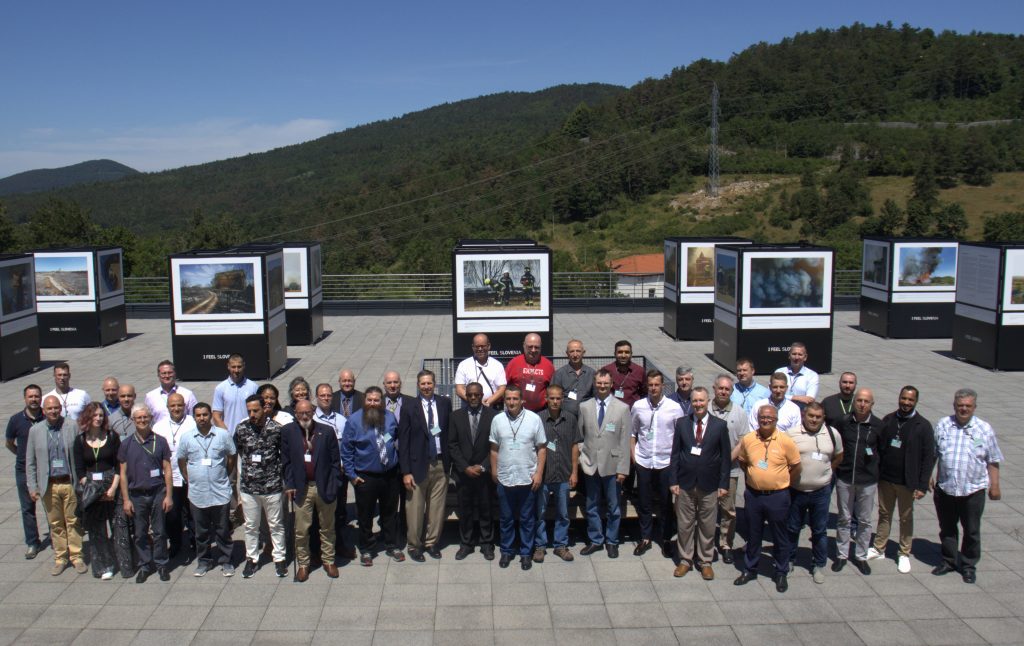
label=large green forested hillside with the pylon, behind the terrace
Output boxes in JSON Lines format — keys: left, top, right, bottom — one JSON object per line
{"left": 5, "top": 25, "right": 1024, "bottom": 273}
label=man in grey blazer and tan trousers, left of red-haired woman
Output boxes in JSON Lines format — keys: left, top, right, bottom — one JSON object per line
{"left": 25, "top": 395, "right": 86, "bottom": 576}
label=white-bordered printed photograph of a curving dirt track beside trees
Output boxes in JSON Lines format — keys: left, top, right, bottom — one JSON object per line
{"left": 171, "top": 258, "right": 264, "bottom": 320}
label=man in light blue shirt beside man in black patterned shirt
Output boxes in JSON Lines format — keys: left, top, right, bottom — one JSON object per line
{"left": 177, "top": 401, "right": 236, "bottom": 576}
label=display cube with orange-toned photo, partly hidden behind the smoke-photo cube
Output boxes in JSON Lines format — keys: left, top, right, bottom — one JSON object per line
{"left": 662, "top": 238, "right": 752, "bottom": 341}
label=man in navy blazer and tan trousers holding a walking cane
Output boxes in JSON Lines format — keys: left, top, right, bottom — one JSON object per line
{"left": 281, "top": 399, "right": 341, "bottom": 583}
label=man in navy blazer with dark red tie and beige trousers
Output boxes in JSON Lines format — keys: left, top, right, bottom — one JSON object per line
{"left": 670, "top": 386, "right": 732, "bottom": 580}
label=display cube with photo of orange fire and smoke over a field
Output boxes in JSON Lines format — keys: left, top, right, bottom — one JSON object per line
{"left": 860, "top": 238, "right": 958, "bottom": 339}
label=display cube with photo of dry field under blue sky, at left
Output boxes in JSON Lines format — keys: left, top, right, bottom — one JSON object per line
{"left": 33, "top": 247, "right": 128, "bottom": 348}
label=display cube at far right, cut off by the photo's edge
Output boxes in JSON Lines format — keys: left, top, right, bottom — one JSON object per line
{"left": 952, "top": 243, "right": 1024, "bottom": 371}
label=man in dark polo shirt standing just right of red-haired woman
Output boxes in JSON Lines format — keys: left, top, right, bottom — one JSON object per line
{"left": 118, "top": 404, "right": 174, "bottom": 584}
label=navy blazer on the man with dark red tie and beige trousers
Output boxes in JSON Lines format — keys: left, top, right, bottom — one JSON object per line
{"left": 669, "top": 415, "right": 732, "bottom": 493}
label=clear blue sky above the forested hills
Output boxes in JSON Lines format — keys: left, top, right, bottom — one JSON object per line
{"left": 0, "top": 0, "right": 1024, "bottom": 177}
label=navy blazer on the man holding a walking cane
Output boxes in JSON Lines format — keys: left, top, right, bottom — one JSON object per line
{"left": 281, "top": 421, "right": 341, "bottom": 505}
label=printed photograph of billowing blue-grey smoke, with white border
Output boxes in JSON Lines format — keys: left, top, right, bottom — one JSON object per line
{"left": 743, "top": 251, "right": 833, "bottom": 314}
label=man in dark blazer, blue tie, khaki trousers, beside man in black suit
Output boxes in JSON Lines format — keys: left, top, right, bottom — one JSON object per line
{"left": 398, "top": 370, "right": 452, "bottom": 562}
